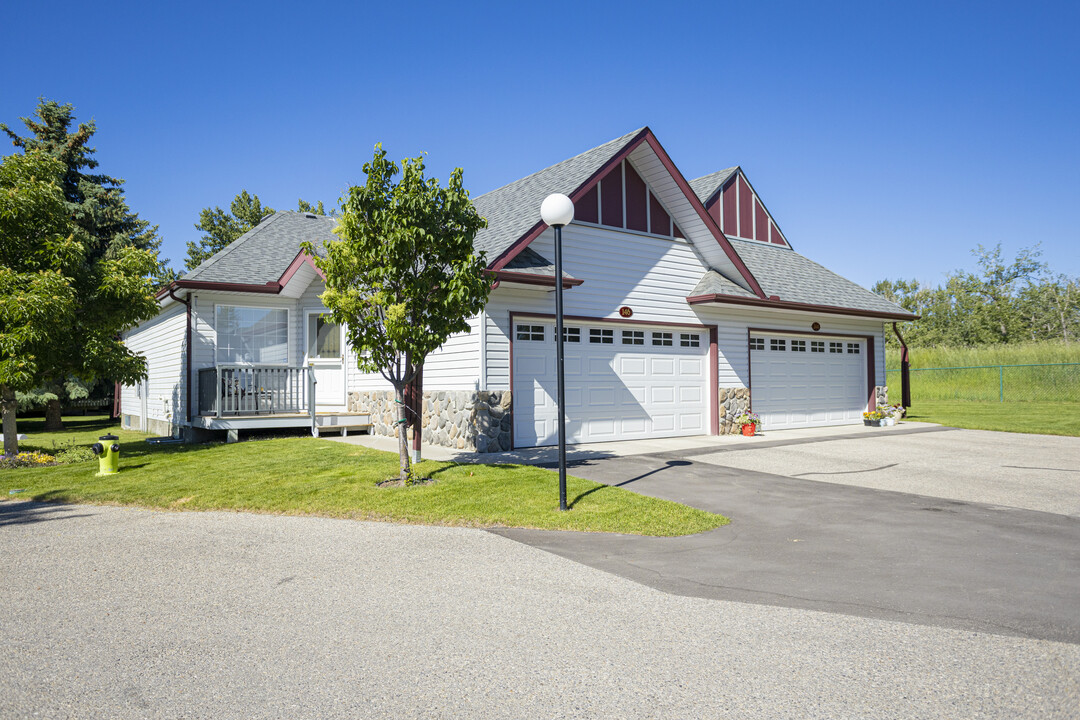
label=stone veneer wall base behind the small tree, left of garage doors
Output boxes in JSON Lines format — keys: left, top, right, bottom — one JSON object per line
{"left": 349, "top": 390, "right": 512, "bottom": 452}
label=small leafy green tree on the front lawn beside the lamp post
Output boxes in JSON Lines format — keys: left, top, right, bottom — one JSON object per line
{"left": 303, "top": 144, "right": 491, "bottom": 484}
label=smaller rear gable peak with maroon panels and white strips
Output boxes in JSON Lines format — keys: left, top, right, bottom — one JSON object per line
{"left": 690, "top": 166, "right": 791, "bottom": 247}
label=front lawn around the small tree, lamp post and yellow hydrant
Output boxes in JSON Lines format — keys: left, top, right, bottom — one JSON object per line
{"left": 0, "top": 418, "right": 728, "bottom": 535}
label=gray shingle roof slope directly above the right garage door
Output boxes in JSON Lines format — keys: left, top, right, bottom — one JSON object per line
{"left": 712, "top": 239, "right": 910, "bottom": 315}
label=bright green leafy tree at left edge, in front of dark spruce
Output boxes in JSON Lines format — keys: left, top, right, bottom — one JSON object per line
{"left": 0, "top": 150, "right": 158, "bottom": 453}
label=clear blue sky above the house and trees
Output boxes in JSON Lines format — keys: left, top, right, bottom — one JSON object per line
{"left": 0, "top": 0, "right": 1080, "bottom": 286}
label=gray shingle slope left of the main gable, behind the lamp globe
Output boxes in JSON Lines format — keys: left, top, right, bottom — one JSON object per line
{"left": 473, "top": 127, "right": 645, "bottom": 264}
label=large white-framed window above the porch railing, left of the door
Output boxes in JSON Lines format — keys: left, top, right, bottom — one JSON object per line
{"left": 215, "top": 305, "right": 288, "bottom": 365}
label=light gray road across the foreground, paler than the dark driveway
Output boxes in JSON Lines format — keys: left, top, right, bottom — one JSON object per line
{"left": 0, "top": 502, "right": 1080, "bottom": 719}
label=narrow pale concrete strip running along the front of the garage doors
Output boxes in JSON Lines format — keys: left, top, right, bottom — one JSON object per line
{"left": 326, "top": 422, "right": 943, "bottom": 465}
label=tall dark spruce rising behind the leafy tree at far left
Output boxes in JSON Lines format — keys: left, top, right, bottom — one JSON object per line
{"left": 0, "top": 98, "right": 175, "bottom": 285}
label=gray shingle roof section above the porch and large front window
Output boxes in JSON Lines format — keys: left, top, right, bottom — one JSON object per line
{"left": 180, "top": 210, "right": 337, "bottom": 285}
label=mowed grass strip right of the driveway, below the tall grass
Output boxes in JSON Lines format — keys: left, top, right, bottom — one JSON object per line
{"left": 907, "top": 397, "right": 1080, "bottom": 436}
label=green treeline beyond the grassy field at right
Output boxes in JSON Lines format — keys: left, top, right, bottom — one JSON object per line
{"left": 873, "top": 245, "right": 1080, "bottom": 348}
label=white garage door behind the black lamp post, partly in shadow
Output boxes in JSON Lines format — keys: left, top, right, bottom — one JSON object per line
{"left": 512, "top": 321, "right": 710, "bottom": 447}
